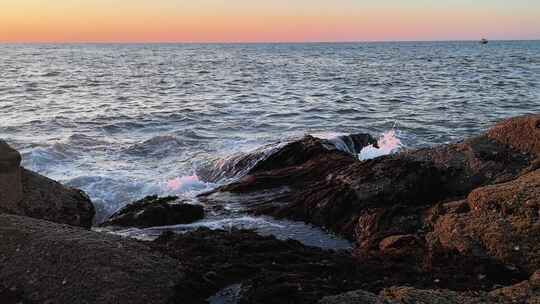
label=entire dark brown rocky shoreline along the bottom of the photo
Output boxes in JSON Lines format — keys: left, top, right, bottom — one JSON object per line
{"left": 0, "top": 114, "right": 540, "bottom": 304}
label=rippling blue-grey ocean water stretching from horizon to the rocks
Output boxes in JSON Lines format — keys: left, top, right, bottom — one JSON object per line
{"left": 0, "top": 41, "right": 540, "bottom": 243}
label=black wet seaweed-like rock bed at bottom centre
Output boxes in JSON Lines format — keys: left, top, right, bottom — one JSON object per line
{"left": 153, "top": 229, "right": 368, "bottom": 303}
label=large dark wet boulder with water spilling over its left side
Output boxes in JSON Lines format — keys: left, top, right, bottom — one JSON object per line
{"left": 201, "top": 119, "right": 535, "bottom": 240}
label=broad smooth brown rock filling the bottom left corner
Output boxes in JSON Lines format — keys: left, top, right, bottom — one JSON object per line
{"left": 0, "top": 214, "right": 183, "bottom": 304}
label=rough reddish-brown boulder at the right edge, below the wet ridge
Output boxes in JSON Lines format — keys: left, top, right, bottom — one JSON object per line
{"left": 428, "top": 170, "right": 540, "bottom": 274}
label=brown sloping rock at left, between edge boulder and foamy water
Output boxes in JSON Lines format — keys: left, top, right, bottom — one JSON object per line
{"left": 16, "top": 168, "right": 95, "bottom": 228}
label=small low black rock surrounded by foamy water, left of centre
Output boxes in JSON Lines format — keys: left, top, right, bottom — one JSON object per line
{"left": 101, "top": 196, "right": 204, "bottom": 228}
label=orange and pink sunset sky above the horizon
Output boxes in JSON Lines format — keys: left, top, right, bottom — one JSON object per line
{"left": 0, "top": 0, "right": 540, "bottom": 42}
